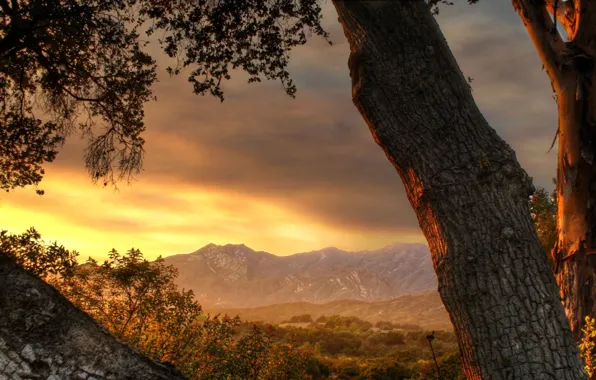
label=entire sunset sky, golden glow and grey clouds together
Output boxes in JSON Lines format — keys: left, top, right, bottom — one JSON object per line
{"left": 0, "top": 0, "right": 556, "bottom": 259}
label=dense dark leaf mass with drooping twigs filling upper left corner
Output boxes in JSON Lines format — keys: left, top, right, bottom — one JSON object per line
{"left": 0, "top": 0, "right": 156, "bottom": 189}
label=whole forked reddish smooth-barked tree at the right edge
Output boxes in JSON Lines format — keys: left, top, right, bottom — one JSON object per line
{"left": 513, "top": 0, "right": 596, "bottom": 339}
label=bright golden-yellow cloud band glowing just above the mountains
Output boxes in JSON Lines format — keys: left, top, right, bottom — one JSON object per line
{"left": 0, "top": 170, "right": 420, "bottom": 260}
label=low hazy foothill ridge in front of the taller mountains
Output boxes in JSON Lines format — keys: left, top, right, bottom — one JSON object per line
{"left": 206, "top": 292, "right": 453, "bottom": 330}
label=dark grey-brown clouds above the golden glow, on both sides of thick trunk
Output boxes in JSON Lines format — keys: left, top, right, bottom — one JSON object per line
{"left": 47, "top": 0, "right": 556, "bottom": 232}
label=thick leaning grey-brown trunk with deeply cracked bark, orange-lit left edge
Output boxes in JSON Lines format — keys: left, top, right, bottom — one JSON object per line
{"left": 333, "top": 0, "right": 587, "bottom": 380}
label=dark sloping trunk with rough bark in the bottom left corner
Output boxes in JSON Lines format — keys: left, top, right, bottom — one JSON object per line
{"left": 0, "top": 252, "right": 184, "bottom": 380}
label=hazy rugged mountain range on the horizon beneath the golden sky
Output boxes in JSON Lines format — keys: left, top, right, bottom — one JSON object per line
{"left": 165, "top": 243, "right": 437, "bottom": 308}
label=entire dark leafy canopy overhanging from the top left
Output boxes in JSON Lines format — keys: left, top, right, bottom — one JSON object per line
{"left": 0, "top": 0, "right": 328, "bottom": 193}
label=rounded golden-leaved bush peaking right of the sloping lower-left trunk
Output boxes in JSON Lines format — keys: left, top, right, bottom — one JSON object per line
{"left": 53, "top": 248, "right": 203, "bottom": 364}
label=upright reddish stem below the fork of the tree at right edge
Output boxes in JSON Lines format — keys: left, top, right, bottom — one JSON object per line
{"left": 553, "top": 71, "right": 596, "bottom": 339}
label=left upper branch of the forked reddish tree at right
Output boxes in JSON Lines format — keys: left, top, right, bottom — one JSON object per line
{"left": 512, "top": 0, "right": 565, "bottom": 92}
